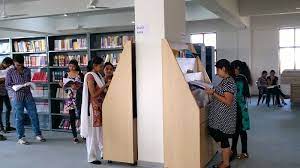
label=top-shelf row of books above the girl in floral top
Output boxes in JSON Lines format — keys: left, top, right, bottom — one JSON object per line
{"left": 54, "top": 38, "right": 87, "bottom": 51}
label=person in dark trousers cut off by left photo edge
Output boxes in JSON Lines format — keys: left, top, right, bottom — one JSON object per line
{"left": 0, "top": 57, "right": 15, "bottom": 133}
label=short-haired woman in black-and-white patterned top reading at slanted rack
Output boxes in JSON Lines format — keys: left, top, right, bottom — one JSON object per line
{"left": 206, "top": 59, "right": 236, "bottom": 168}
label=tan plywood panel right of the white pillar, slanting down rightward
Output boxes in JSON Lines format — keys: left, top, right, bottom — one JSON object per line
{"left": 162, "top": 40, "right": 214, "bottom": 168}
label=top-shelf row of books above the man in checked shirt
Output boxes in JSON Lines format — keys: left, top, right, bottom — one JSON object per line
{"left": 14, "top": 40, "right": 46, "bottom": 52}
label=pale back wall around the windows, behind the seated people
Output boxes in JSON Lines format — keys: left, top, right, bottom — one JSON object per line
{"left": 187, "top": 14, "right": 300, "bottom": 94}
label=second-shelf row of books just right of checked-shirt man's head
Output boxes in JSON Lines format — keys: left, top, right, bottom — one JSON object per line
{"left": 24, "top": 54, "right": 48, "bottom": 67}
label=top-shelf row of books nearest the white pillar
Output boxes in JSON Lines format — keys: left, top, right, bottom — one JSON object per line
{"left": 100, "top": 35, "right": 134, "bottom": 48}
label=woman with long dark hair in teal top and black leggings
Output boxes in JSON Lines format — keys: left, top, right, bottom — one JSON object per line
{"left": 231, "top": 60, "right": 252, "bottom": 159}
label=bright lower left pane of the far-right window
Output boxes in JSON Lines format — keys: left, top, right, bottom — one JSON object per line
{"left": 280, "top": 48, "right": 295, "bottom": 72}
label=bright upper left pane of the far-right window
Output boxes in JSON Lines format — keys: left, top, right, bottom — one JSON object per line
{"left": 279, "top": 29, "right": 295, "bottom": 47}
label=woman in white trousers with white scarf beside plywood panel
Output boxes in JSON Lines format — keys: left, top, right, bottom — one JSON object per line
{"left": 80, "top": 57, "right": 109, "bottom": 164}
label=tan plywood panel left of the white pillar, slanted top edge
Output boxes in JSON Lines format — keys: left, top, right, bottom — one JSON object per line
{"left": 103, "top": 42, "right": 137, "bottom": 164}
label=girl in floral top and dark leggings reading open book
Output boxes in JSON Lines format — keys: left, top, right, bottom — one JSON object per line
{"left": 60, "top": 60, "right": 84, "bottom": 144}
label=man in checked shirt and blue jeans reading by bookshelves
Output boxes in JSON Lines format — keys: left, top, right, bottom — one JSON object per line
{"left": 5, "top": 55, "right": 46, "bottom": 145}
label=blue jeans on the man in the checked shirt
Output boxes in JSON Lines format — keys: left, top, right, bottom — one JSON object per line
{"left": 13, "top": 98, "right": 42, "bottom": 139}
